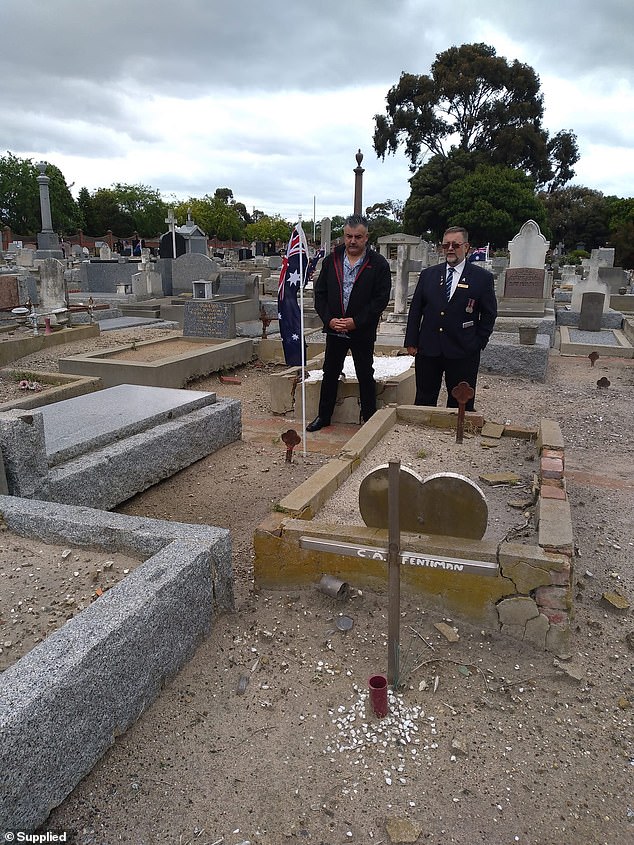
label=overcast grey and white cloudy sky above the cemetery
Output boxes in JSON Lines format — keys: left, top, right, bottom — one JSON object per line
{"left": 0, "top": 0, "right": 634, "bottom": 221}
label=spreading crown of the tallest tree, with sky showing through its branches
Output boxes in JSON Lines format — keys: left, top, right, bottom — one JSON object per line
{"left": 373, "top": 44, "right": 579, "bottom": 187}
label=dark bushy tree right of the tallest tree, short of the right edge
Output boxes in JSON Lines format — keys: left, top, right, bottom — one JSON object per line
{"left": 540, "top": 185, "right": 608, "bottom": 252}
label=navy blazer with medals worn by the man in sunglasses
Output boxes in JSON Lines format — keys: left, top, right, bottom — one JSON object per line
{"left": 404, "top": 261, "right": 497, "bottom": 358}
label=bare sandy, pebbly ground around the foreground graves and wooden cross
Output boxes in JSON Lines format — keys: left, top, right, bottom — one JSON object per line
{"left": 2, "top": 332, "right": 634, "bottom": 845}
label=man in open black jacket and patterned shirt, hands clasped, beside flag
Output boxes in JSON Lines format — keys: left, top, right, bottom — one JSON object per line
{"left": 306, "top": 214, "right": 391, "bottom": 431}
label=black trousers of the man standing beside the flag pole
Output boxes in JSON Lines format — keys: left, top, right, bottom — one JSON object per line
{"left": 319, "top": 334, "right": 376, "bottom": 422}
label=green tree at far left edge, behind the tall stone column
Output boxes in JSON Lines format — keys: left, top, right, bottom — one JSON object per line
{"left": 0, "top": 152, "right": 81, "bottom": 235}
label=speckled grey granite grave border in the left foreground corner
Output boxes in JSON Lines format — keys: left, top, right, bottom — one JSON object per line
{"left": 0, "top": 496, "right": 234, "bottom": 831}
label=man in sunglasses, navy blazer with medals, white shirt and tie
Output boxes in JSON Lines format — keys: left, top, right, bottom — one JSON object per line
{"left": 404, "top": 226, "right": 497, "bottom": 411}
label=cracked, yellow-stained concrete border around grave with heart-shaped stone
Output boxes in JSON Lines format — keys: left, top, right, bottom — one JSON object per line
{"left": 254, "top": 405, "right": 573, "bottom": 655}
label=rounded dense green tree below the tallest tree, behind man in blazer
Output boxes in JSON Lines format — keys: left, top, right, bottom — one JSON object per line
{"left": 448, "top": 165, "right": 549, "bottom": 248}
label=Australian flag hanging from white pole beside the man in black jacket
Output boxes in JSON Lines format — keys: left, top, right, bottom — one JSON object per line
{"left": 277, "top": 223, "right": 308, "bottom": 367}
